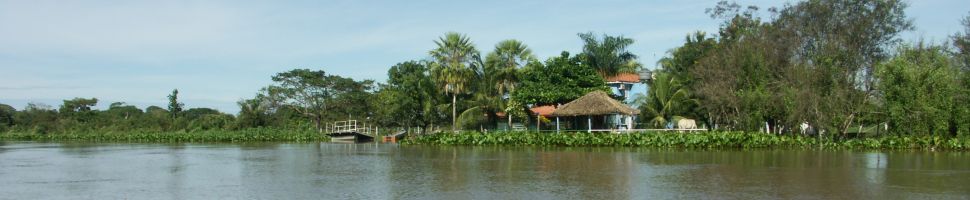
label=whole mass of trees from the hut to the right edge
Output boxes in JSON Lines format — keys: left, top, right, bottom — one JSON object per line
{"left": 637, "top": 0, "right": 970, "bottom": 139}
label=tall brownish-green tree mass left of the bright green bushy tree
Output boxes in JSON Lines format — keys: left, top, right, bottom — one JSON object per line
{"left": 676, "top": 0, "right": 912, "bottom": 136}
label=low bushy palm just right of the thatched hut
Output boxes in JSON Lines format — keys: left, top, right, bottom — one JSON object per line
{"left": 640, "top": 73, "right": 699, "bottom": 127}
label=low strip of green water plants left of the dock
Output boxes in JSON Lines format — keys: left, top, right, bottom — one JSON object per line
{"left": 0, "top": 128, "right": 330, "bottom": 142}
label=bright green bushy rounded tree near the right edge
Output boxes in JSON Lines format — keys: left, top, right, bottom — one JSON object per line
{"left": 876, "top": 44, "right": 965, "bottom": 136}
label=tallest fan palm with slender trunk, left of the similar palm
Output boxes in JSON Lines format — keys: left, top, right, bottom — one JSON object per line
{"left": 429, "top": 32, "right": 478, "bottom": 131}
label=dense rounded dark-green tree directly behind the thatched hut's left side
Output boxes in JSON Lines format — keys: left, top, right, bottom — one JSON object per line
{"left": 512, "top": 51, "right": 609, "bottom": 105}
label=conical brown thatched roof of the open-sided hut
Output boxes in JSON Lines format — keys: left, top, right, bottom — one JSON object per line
{"left": 552, "top": 91, "right": 640, "bottom": 117}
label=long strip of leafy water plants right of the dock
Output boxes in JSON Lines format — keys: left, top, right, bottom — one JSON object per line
{"left": 401, "top": 131, "right": 970, "bottom": 150}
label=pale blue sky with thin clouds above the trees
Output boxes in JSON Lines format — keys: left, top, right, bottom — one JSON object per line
{"left": 0, "top": 0, "right": 970, "bottom": 113}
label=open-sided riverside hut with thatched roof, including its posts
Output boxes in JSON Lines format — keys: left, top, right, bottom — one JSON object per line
{"left": 550, "top": 91, "right": 640, "bottom": 132}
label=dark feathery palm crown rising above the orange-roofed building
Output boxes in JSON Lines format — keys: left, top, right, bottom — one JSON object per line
{"left": 577, "top": 32, "right": 640, "bottom": 78}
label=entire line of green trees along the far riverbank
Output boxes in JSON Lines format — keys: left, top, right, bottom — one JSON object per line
{"left": 0, "top": 0, "right": 970, "bottom": 137}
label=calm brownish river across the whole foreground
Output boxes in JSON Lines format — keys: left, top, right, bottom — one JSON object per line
{"left": 0, "top": 142, "right": 970, "bottom": 199}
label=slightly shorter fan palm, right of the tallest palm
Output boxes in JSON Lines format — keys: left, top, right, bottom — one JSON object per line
{"left": 485, "top": 40, "right": 537, "bottom": 127}
